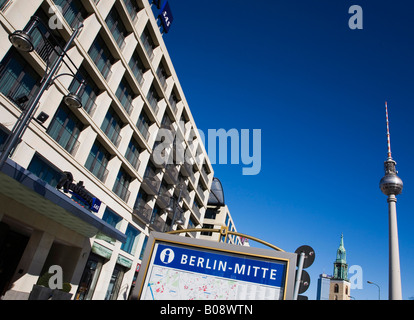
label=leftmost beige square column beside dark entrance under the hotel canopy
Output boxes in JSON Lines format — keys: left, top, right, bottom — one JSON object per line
{"left": 4, "top": 230, "right": 55, "bottom": 300}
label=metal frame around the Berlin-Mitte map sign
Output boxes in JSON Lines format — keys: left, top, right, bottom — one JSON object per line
{"left": 130, "top": 232, "right": 297, "bottom": 300}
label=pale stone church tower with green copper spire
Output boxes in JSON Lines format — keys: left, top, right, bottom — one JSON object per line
{"left": 329, "top": 234, "right": 351, "bottom": 300}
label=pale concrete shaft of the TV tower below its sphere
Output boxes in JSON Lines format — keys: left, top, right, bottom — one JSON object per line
{"left": 388, "top": 194, "right": 402, "bottom": 300}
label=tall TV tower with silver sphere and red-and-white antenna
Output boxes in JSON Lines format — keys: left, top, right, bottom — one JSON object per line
{"left": 380, "top": 102, "right": 403, "bottom": 300}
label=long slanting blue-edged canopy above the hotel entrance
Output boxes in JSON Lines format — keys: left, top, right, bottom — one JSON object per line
{"left": 0, "top": 159, "right": 126, "bottom": 242}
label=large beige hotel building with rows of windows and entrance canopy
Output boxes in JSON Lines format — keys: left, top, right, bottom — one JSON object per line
{"left": 0, "top": 0, "right": 214, "bottom": 300}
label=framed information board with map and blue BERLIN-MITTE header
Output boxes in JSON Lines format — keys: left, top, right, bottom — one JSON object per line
{"left": 131, "top": 232, "right": 297, "bottom": 300}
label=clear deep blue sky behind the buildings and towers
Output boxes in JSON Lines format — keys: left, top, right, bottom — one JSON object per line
{"left": 158, "top": 0, "right": 414, "bottom": 300}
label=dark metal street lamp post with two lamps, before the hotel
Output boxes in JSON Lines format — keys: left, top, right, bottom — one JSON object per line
{"left": 0, "top": 16, "right": 85, "bottom": 169}
